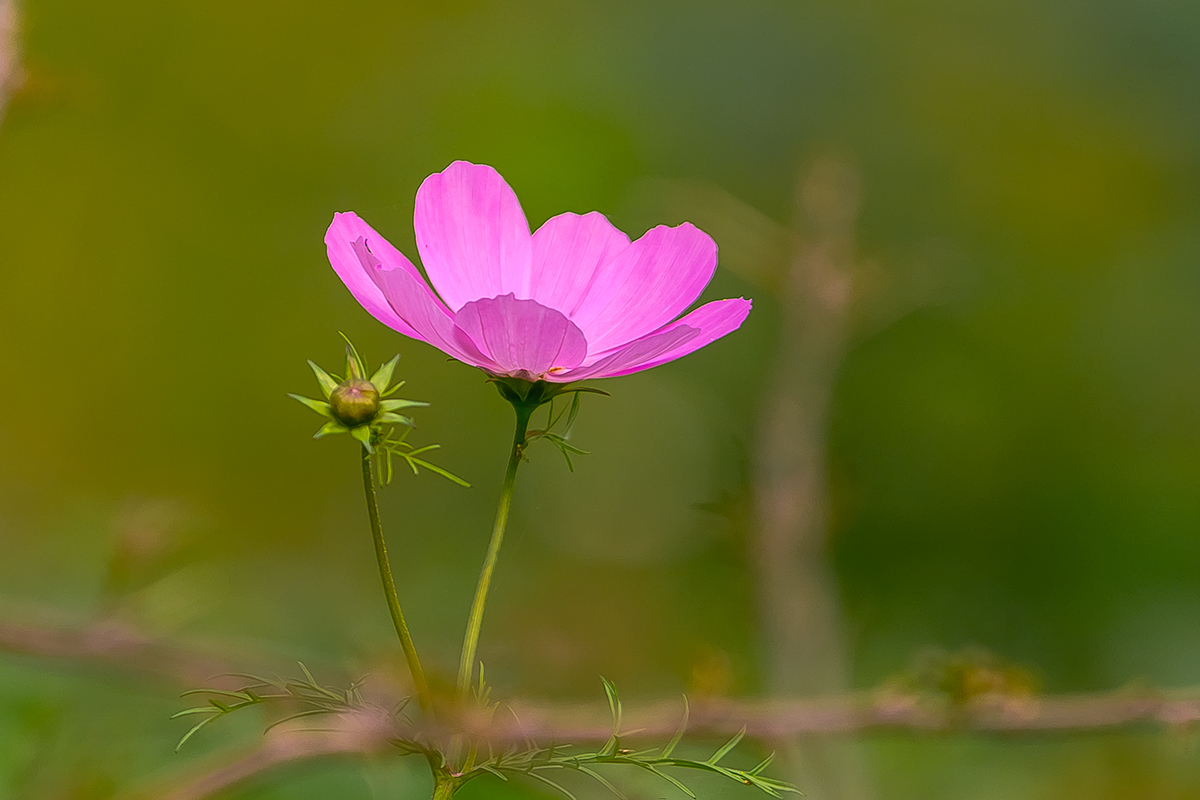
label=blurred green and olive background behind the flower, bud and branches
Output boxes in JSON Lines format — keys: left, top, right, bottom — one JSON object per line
{"left": 0, "top": 0, "right": 1200, "bottom": 800}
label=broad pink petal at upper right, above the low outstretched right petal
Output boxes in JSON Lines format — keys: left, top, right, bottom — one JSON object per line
{"left": 571, "top": 222, "right": 716, "bottom": 353}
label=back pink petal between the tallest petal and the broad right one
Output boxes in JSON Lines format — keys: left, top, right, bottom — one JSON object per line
{"left": 529, "top": 211, "right": 629, "bottom": 317}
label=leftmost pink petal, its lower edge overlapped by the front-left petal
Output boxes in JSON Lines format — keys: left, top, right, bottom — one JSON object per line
{"left": 325, "top": 212, "right": 421, "bottom": 338}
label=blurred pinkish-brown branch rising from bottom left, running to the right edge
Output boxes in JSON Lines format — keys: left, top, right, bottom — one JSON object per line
{"left": 136, "top": 687, "right": 1200, "bottom": 800}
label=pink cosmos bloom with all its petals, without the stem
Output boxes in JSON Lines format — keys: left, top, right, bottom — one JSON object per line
{"left": 325, "top": 161, "right": 750, "bottom": 383}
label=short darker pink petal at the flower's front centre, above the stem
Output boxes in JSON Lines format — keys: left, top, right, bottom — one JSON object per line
{"left": 454, "top": 293, "right": 588, "bottom": 380}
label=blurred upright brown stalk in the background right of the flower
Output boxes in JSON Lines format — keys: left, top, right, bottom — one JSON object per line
{"left": 754, "top": 156, "right": 875, "bottom": 800}
